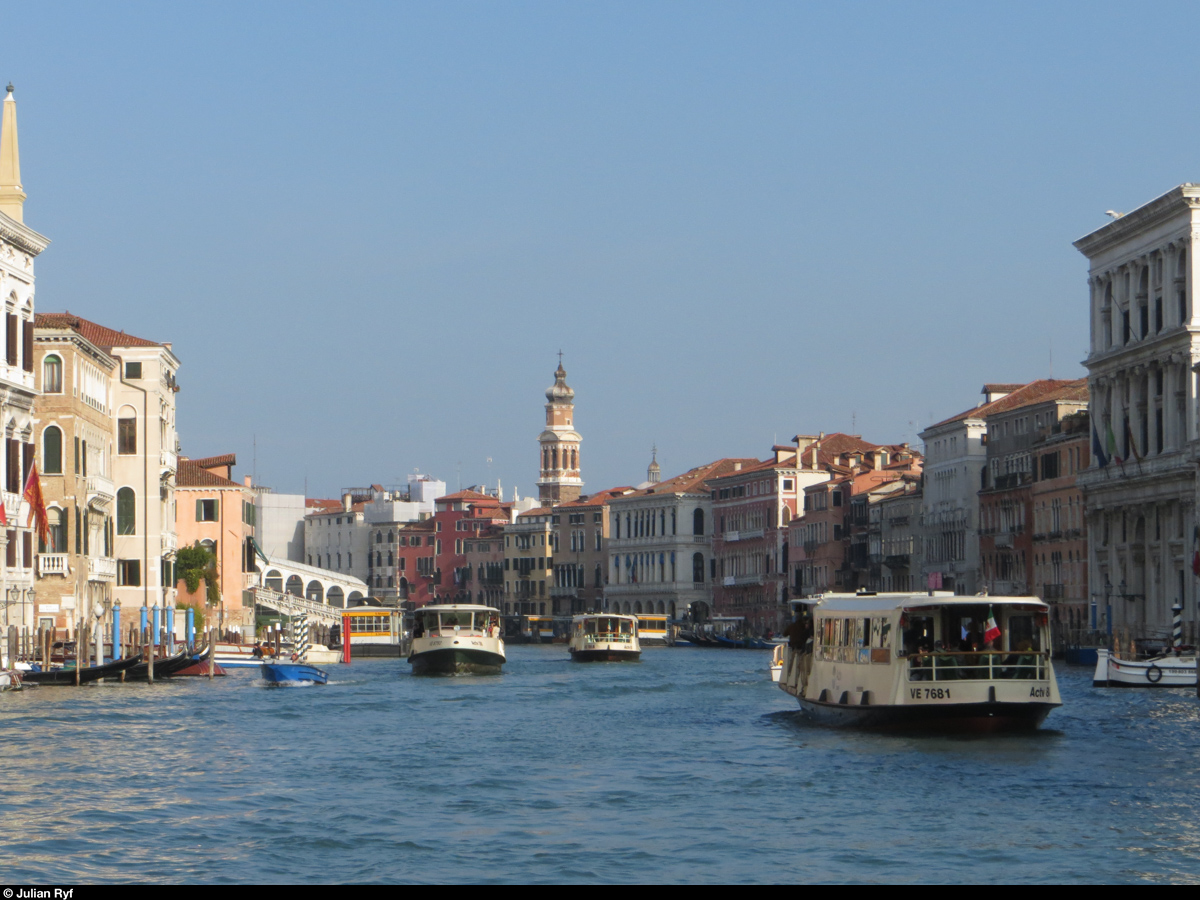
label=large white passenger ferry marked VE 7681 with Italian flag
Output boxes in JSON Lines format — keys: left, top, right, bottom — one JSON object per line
{"left": 779, "top": 592, "right": 1062, "bottom": 732}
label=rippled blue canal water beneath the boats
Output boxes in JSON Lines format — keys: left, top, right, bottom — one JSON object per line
{"left": 0, "top": 647, "right": 1200, "bottom": 883}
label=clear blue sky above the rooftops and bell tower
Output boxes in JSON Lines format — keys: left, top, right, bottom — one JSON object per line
{"left": 0, "top": 1, "right": 1200, "bottom": 496}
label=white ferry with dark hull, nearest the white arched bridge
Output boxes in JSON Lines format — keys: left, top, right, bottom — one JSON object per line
{"left": 408, "top": 604, "right": 506, "bottom": 674}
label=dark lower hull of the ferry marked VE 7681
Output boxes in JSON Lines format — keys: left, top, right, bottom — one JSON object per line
{"left": 798, "top": 697, "right": 1061, "bottom": 734}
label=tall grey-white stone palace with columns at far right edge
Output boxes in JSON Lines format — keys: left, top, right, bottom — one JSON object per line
{"left": 1075, "top": 184, "right": 1200, "bottom": 637}
